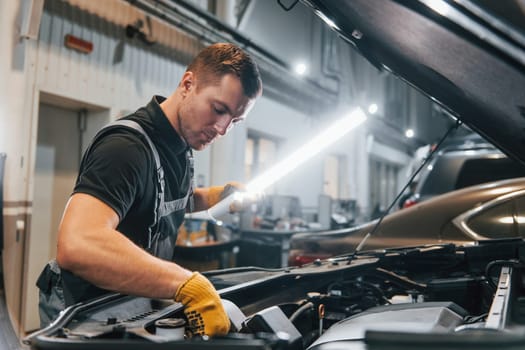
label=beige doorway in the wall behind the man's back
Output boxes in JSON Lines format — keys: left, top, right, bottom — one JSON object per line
{"left": 22, "top": 94, "right": 109, "bottom": 332}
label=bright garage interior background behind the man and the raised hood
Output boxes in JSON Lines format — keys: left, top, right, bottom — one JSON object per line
{"left": 0, "top": 0, "right": 468, "bottom": 335}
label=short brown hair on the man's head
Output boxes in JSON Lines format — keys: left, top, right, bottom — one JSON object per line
{"left": 186, "top": 43, "right": 262, "bottom": 98}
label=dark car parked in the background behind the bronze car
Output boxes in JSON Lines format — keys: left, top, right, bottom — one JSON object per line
{"left": 402, "top": 134, "right": 525, "bottom": 208}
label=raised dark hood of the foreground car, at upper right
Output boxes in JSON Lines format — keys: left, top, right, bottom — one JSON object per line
{"left": 303, "top": 0, "right": 525, "bottom": 162}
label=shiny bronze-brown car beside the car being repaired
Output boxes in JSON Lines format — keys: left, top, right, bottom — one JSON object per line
{"left": 288, "top": 177, "right": 525, "bottom": 266}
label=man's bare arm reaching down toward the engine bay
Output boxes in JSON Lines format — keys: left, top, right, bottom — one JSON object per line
{"left": 57, "top": 193, "right": 191, "bottom": 298}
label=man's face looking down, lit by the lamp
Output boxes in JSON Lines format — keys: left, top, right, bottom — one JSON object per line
{"left": 177, "top": 74, "right": 254, "bottom": 151}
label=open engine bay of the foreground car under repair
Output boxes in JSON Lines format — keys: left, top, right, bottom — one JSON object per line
{"left": 26, "top": 240, "right": 525, "bottom": 350}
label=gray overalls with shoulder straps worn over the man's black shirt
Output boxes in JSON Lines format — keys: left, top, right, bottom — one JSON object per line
{"left": 36, "top": 120, "right": 193, "bottom": 328}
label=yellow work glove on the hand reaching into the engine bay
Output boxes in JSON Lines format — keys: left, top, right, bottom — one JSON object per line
{"left": 174, "top": 272, "right": 230, "bottom": 337}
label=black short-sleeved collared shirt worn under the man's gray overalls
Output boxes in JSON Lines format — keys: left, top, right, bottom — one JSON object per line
{"left": 63, "top": 96, "right": 191, "bottom": 304}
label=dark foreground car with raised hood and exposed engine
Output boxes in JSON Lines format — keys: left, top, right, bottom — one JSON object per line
{"left": 24, "top": 0, "right": 525, "bottom": 350}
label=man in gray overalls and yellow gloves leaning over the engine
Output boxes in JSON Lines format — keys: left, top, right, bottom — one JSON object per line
{"left": 37, "top": 43, "right": 262, "bottom": 336}
